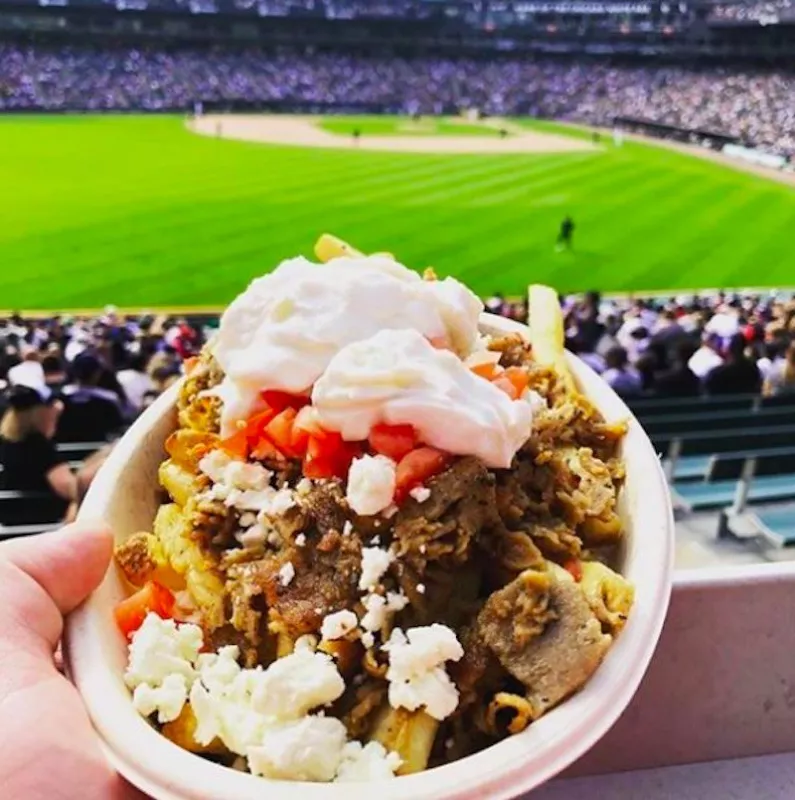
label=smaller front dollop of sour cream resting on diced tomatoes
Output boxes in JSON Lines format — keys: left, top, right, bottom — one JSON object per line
{"left": 312, "top": 330, "right": 533, "bottom": 468}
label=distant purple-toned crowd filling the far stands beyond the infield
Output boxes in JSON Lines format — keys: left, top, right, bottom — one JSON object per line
{"left": 0, "top": 44, "right": 795, "bottom": 154}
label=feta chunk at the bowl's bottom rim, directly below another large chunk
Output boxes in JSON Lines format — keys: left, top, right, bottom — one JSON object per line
{"left": 248, "top": 717, "right": 347, "bottom": 782}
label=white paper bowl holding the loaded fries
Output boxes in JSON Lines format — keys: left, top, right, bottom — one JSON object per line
{"left": 65, "top": 315, "right": 674, "bottom": 800}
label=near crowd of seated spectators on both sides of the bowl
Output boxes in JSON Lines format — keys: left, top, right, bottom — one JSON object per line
{"left": 0, "top": 293, "right": 795, "bottom": 524}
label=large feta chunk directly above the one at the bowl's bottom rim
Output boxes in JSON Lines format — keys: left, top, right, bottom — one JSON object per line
{"left": 253, "top": 648, "right": 345, "bottom": 722}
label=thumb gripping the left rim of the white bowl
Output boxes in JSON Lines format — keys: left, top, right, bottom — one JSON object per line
{"left": 0, "top": 522, "right": 113, "bottom": 616}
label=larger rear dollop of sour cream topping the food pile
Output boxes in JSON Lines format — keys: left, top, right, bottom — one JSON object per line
{"left": 213, "top": 256, "right": 483, "bottom": 435}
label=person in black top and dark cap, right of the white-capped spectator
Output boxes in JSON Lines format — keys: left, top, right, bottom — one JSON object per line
{"left": 58, "top": 353, "right": 124, "bottom": 442}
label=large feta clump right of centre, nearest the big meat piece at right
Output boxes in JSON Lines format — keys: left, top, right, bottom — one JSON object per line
{"left": 384, "top": 623, "right": 464, "bottom": 720}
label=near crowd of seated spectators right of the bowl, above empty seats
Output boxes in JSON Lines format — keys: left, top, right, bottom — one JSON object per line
{"left": 486, "top": 293, "right": 795, "bottom": 400}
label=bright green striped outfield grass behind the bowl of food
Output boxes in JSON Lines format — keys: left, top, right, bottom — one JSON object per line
{"left": 0, "top": 116, "right": 795, "bottom": 309}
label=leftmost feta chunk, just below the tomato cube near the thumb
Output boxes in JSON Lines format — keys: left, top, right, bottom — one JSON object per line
{"left": 124, "top": 613, "right": 203, "bottom": 689}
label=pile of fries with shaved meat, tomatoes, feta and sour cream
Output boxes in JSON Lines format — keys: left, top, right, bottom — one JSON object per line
{"left": 116, "top": 237, "right": 633, "bottom": 781}
